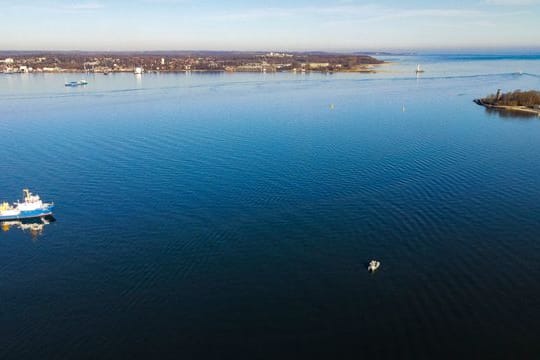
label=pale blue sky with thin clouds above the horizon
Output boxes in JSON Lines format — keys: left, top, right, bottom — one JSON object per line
{"left": 0, "top": 0, "right": 540, "bottom": 50}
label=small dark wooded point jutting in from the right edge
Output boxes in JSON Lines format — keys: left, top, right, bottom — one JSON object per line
{"left": 474, "top": 89, "right": 540, "bottom": 116}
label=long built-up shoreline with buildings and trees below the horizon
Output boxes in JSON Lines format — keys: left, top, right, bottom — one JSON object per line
{"left": 0, "top": 51, "right": 384, "bottom": 74}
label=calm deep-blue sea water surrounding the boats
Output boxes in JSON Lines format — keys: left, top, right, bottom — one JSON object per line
{"left": 0, "top": 55, "right": 540, "bottom": 359}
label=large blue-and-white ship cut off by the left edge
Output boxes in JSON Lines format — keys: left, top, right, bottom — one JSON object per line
{"left": 0, "top": 189, "right": 54, "bottom": 221}
